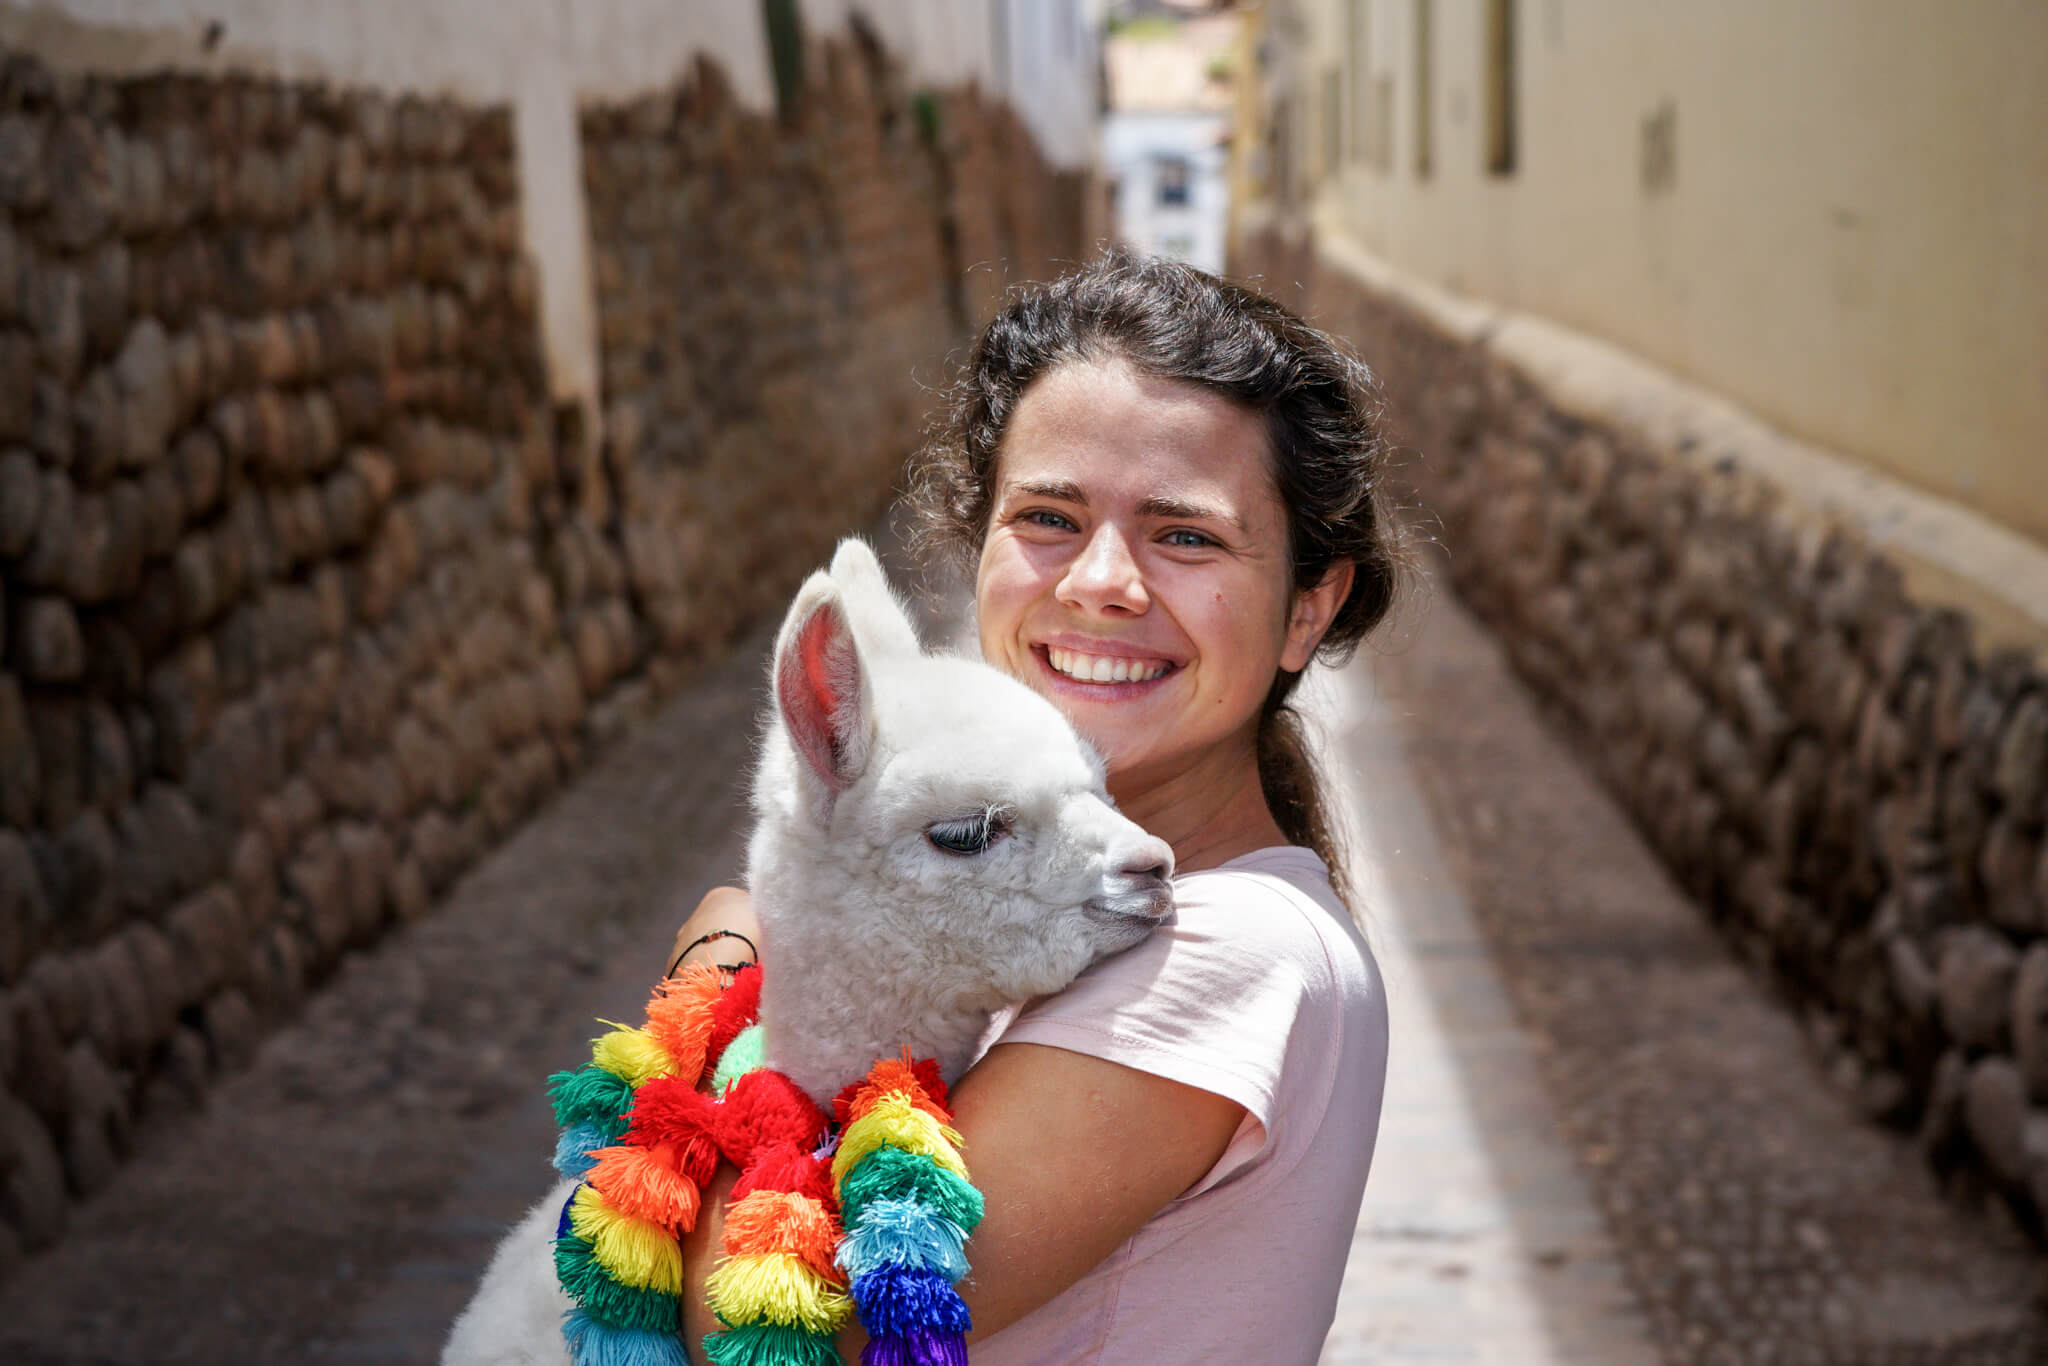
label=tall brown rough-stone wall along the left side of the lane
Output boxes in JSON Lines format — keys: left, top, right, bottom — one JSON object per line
{"left": 0, "top": 29, "right": 1079, "bottom": 1272}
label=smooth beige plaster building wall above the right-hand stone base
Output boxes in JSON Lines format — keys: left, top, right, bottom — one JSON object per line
{"left": 1270, "top": 0, "right": 2048, "bottom": 541}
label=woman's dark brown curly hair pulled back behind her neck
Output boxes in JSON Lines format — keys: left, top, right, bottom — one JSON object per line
{"left": 903, "top": 250, "right": 1407, "bottom": 891}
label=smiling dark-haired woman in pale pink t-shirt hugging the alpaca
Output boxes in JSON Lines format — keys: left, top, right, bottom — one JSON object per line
{"left": 678, "top": 254, "right": 1401, "bottom": 1366}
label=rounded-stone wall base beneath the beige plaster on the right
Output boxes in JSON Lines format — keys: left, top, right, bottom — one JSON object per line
{"left": 1239, "top": 231, "right": 2048, "bottom": 1235}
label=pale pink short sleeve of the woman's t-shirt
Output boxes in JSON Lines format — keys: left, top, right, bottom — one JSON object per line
{"left": 995, "top": 870, "right": 1335, "bottom": 1190}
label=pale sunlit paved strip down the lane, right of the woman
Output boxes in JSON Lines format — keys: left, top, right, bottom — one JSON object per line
{"left": 1313, "top": 657, "right": 1657, "bottom": 1366}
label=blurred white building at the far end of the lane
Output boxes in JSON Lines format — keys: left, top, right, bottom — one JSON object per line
{"left": 1102, "top": 12, "right": 1237, "bottom": 272}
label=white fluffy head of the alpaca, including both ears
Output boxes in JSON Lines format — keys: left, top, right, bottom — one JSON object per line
{"left": 750, "top": 541, "right": 1174, "bottom": 1010}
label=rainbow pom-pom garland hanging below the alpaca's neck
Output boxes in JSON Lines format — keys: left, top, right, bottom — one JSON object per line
{"left": 549, "top": 967, "right": 981, "bottom": 1366}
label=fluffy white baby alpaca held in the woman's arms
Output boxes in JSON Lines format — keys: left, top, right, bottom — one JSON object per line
{"left": 440, "top": 541, "right": 1174, "bottom": 1366}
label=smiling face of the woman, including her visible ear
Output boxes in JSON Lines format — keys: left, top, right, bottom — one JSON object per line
{"left": 975, "top": 362, "right": 1350, "bottom": 795}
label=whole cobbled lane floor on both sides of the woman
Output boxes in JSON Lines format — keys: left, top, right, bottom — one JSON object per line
{"left": 0, "top": 561, "right": 2048, "bottom": 1366}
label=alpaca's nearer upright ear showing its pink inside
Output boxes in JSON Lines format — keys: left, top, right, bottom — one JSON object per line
{"left": 774, "top": 589, "right": 872, "bottom": 793}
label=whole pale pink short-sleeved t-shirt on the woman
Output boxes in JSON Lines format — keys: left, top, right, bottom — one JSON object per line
{"left": 969, "top": 846, "right": 1386, "bottom": 1366}
